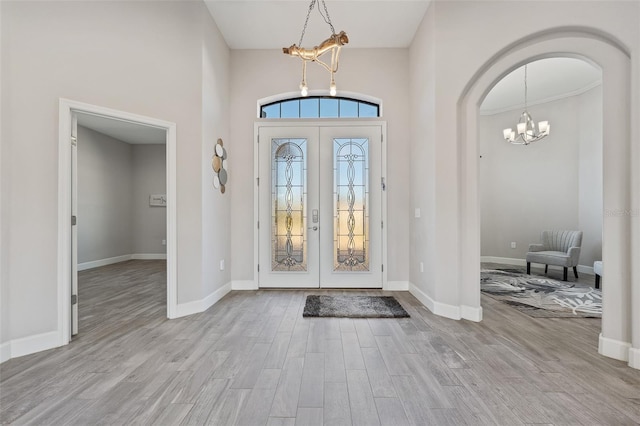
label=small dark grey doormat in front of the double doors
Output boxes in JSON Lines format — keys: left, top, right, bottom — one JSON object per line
{"left": 302, "top": 295, "right": 409, "bottom": 318}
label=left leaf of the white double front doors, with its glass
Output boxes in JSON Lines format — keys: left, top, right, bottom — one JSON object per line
{"left": 258, "top": 127, "right": 319, "bottom": 288}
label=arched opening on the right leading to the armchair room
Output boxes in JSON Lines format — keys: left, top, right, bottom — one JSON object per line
{"left": 478, "top": 57, "right": 603, "bottom": 316}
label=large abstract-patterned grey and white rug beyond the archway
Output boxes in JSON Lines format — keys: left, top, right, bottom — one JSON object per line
{"left": 480, "top": 269, "right": 602, "bottom": 318}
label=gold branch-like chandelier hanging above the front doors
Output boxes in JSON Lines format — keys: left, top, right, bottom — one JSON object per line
{"left": 282, "top": 0, "right": 349, "bottom": 96}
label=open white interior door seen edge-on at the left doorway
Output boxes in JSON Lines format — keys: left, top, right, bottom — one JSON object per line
{"left": 71, "top": 113, "right": 78, "bottom": 336}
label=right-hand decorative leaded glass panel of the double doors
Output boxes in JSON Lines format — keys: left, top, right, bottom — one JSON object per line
{"left": 333, "top": 138, "right": 369, "bottom": 271}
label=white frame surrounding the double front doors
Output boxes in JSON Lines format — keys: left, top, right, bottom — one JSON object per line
{"left": 253, "top": 119, "right": 391, "bottom": 290}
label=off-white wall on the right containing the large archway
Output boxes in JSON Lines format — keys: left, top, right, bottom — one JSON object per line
{"left": 410, "top": 1, "right": 640, "bottom": 366}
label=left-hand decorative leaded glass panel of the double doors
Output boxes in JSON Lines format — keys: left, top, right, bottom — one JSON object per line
{"left": 271, "top": 139, "right": 307, "bottom": 271}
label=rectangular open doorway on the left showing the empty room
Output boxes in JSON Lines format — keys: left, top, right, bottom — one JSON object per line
{"left": 72, "top": 112, "right": 167, "bottom": 335}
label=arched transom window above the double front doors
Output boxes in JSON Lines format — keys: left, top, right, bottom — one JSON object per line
{"left": 260, "top": 96, "right": 380, "bottom": 118}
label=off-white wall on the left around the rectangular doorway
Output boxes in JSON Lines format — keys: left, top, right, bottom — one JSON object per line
{"left": 0, "top": 1, "right": 229, "bottom": 356}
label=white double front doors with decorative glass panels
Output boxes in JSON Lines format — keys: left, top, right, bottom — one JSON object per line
{"left": 258, "top": 124, "right": 384, "bottom": 288}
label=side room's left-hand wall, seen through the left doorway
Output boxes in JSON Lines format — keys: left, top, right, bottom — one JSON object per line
{"left": 78, "top": 126, "right": 133, "bottom": 264}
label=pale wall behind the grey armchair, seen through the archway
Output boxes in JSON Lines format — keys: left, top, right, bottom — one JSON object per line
{"left": 479, "top": 87, "right": 602, "bottom": 267}
